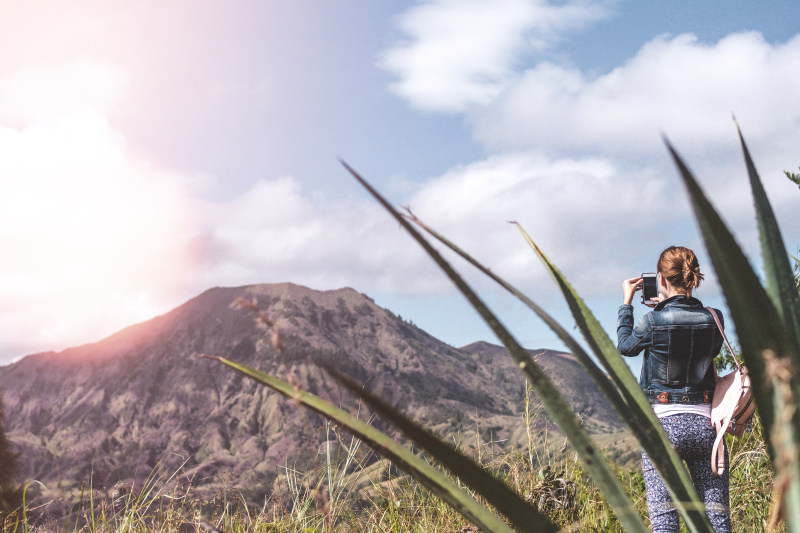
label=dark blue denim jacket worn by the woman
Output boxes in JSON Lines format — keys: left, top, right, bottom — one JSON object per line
{"left": 617, "top": 295, "right": 723, "bottom": 404}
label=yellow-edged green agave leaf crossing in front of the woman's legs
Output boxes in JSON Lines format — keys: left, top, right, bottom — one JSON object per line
{"left": 517, "top": 224, "right": 712, "bottom": 532}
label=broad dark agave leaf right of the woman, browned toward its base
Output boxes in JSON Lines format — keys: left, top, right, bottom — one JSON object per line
{"left": 665, "top": 141, "right": 800, "bottom": 532}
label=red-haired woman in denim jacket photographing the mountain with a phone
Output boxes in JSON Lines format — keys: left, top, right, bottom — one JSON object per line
{"left": 617, "top": 246, "right": 731, "bottom": 533}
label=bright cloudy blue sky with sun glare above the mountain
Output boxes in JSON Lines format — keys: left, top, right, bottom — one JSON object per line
{"left": 0, "top": 0, "right": 800, "bottom": 364}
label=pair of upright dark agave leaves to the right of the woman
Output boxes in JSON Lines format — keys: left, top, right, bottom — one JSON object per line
{"left": 669, "top": 125, "right": 800, "bottom": 532}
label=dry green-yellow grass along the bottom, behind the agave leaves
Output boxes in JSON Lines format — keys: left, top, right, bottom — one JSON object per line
{"left": 0, "top": 401, "right": 783, "bottom": 533}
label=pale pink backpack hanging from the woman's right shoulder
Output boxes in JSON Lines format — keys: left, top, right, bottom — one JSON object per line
{"left": 706, "top": 307, "right": 756, "bottom": 476}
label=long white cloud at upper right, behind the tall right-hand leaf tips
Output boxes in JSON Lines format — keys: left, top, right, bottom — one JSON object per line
{"left": 475, "top": 33, "right": 800, "bottom": 157}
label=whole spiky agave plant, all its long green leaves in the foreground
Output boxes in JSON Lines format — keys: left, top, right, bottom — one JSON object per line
{"left": 209, "top": 125, "right": 800, "bottom": 533}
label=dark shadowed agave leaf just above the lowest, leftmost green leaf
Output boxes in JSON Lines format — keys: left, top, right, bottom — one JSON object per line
{"left": 325, "top": 366, "right": 560, "bottom": 532}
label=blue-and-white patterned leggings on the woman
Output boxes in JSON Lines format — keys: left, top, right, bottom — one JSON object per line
{"left": 642, "top": 413, "right": 731, "bottom": 533}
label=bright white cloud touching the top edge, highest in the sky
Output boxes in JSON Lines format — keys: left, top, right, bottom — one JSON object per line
{"left": 380, "top": 0, "right": 607, "bottom": 112}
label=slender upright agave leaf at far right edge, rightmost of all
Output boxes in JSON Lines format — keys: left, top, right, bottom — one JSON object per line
{"left": 736, "top": 124, "right": 800, "bottom": 356}
